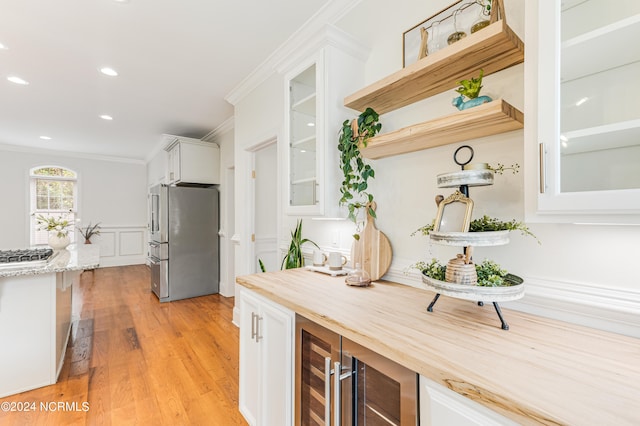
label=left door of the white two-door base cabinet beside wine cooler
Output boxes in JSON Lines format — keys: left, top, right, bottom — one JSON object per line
{"left": 238, "top": 290, "right": 260, "bottom": 425}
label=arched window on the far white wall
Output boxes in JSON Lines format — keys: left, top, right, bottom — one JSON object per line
{"left": 29, "top": 166, "right": 78, "bottom": 245}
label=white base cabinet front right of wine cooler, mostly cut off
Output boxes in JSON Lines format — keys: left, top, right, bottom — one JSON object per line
{"left": 419, "top": 376, "right": 517, "bottom": 426}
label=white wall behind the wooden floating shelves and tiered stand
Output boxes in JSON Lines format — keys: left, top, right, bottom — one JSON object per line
{"left": 230, "top": 0, "right": 640, "bottom": 335}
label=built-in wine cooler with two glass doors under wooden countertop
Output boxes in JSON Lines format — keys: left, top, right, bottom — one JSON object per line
{"left": 295, "top": 316, "right": 419, "bottom": 426}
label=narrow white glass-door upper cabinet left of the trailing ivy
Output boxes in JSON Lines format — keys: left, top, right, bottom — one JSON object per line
{"left": 280, "top": 27, "right": 364, "bottom": 217}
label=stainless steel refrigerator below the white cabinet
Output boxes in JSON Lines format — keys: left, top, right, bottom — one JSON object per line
{"left": 149, "top": 185, "right": 220, "bottom": 302}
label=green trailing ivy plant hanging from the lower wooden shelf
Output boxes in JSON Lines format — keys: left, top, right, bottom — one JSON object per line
{"left": 338, "top": 108, "right": 382, "bottom": 240}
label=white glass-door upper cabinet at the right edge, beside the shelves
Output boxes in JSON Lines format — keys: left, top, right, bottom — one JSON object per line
{"left": 537, "top": 0, "right": 640, "bottom": 222}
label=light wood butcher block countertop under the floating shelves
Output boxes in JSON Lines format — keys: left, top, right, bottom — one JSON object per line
{"left": 236, "top": 269, "right": 640, "bottom": 426}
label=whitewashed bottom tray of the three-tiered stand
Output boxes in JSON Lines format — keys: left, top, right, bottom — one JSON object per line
{"left": 422, "top": 274, "right": 524, "bottom": 302}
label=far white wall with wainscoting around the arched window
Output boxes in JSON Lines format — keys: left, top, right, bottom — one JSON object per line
{"left": 0, "top": 146, "right": 146, "bottom": 266}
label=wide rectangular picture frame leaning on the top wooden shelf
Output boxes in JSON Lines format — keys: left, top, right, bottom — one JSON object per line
{"left": 402, "top": 0, "right": 503, "bottom": 68}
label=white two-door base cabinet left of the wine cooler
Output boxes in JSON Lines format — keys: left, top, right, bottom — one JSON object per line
{"left": 238, "top": 288, "right": 295, "bottom": 426}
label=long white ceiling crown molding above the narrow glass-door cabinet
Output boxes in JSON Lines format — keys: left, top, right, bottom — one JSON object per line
{"left": 224, "top": 0, "right": 366, "bottom": 105}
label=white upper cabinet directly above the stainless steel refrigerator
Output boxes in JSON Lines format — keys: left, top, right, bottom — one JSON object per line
{"left": 165, "top": 137, "right": 220, "bottom": 184}
